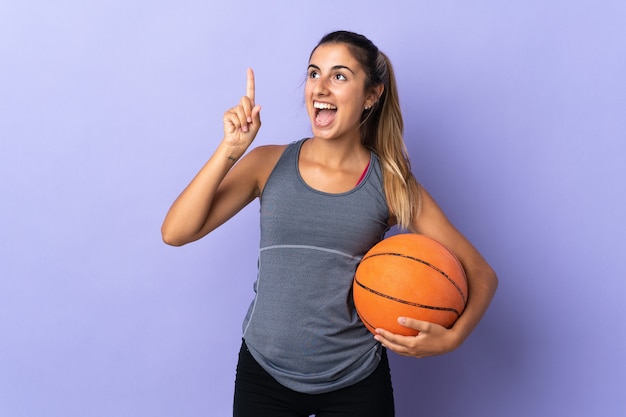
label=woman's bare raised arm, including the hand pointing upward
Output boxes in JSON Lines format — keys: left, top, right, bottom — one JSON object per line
{"left": 161, "top": 69, "right": 263, "bottom": 246}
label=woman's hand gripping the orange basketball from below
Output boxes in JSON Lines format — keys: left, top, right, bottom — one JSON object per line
{"left": 374, "top": 317, "right": 461, "bottom": 358}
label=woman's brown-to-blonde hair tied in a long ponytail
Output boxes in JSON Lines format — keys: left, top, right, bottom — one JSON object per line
{"left": 318, "top": 31, "right": 421, "bottom": 229}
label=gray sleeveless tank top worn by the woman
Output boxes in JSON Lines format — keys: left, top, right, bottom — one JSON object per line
{"left": 243, "top": 139, "right": 389, "bottom": 394}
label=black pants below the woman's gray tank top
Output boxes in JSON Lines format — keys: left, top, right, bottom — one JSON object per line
{"left": 233, "top": 343, "right": 395, "bottom": 417}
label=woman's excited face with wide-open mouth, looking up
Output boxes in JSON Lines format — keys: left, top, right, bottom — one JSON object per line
{"left": 304, "top": 43, "right": 372, "bottom": 140}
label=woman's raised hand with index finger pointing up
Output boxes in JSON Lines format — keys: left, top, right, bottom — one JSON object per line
{"left": 223, "top": 68, "right": 261, "bottom": 159}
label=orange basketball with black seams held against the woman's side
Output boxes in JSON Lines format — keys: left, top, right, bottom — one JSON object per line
{"left": 352, "top": 233, "right": 467, "bottom": 336}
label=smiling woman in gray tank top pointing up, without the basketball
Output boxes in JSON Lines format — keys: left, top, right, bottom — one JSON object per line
{"left": 162, "top": 31, "right": 497, "bottom": 417}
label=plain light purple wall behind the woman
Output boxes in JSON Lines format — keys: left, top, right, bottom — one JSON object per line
{"left": 0, "top": 0, "right": 626, "bottom": 417}
